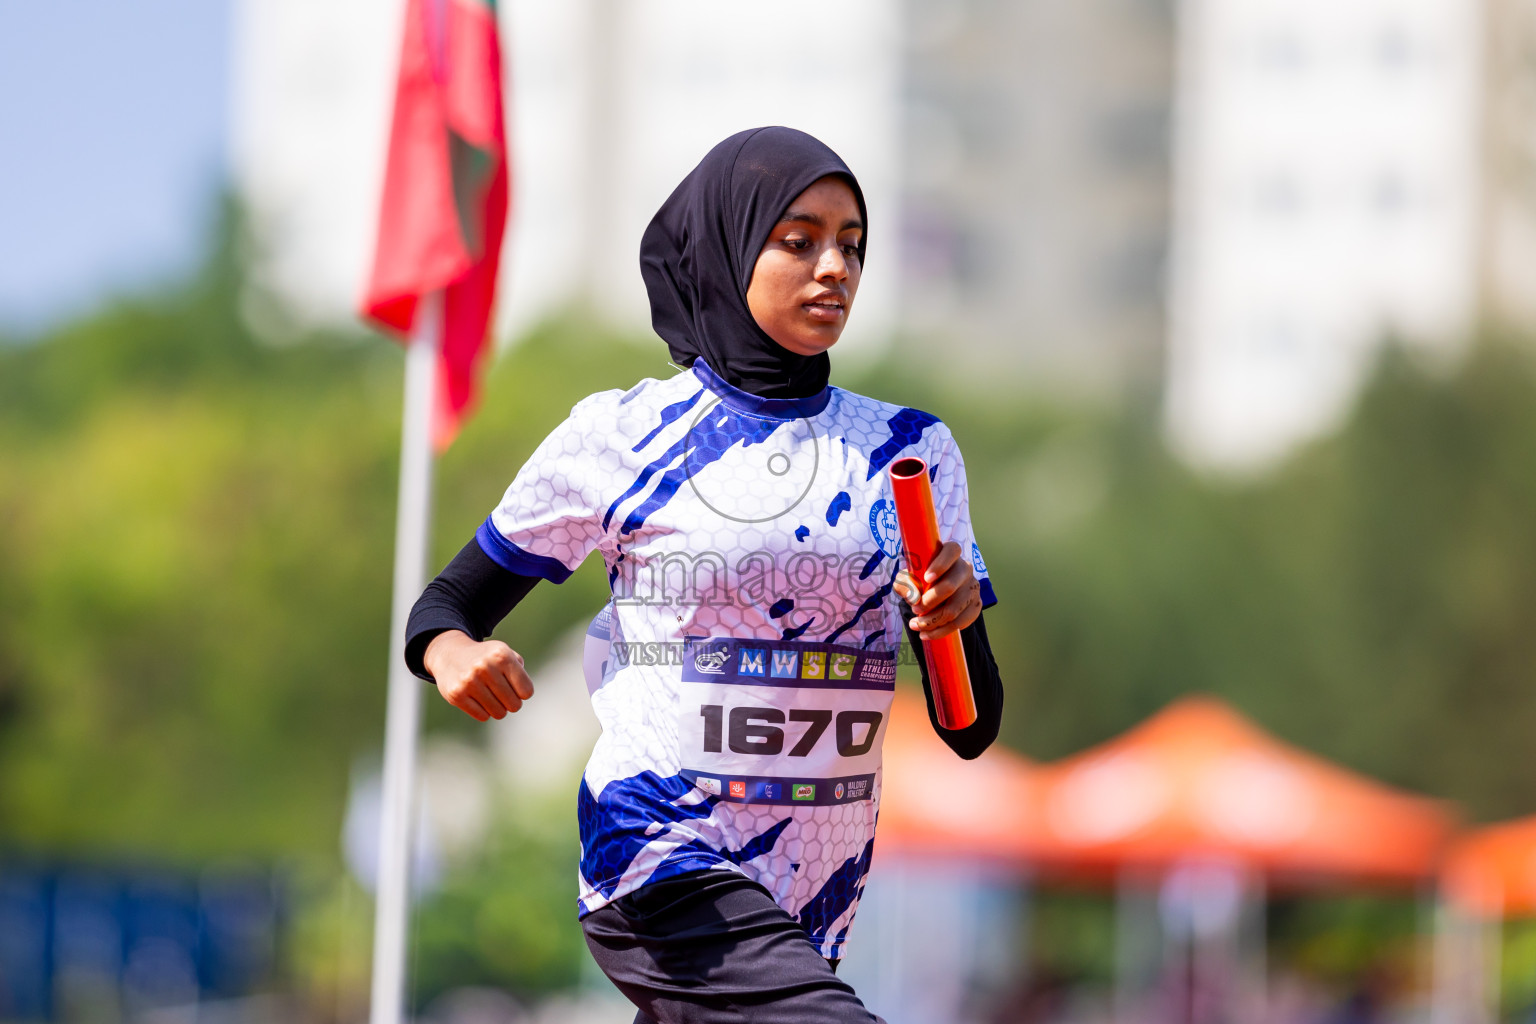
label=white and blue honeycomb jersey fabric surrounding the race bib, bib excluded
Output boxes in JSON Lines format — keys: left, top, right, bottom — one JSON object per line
{"left": 490, "top": 373, "right": 983, "bottom": 955}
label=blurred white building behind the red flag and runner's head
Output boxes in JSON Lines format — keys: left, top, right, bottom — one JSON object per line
{"left": 233, "top": 0, "right": 897, "bottom": 356}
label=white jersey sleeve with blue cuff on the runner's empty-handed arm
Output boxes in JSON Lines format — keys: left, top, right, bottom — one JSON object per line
{"left": 475, "top": 395, "right": 607, "bottom": 583}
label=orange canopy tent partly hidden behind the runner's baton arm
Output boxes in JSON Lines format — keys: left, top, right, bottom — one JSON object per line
{"left": 877, "top": 689, "right": 1041, "bottom": 863}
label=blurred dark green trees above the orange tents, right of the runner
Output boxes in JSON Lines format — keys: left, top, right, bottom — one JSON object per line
{"left": 935, "top": 339, "right": 1536, "bottom": 818}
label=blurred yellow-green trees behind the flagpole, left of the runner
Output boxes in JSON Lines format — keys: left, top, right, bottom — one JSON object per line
{"left": 0, "top": 202, "right": 667, "bottom": 863}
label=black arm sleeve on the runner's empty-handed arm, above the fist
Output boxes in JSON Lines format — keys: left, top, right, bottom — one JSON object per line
{"left": 406, "top": 537, "right": 539, "bottom": 683}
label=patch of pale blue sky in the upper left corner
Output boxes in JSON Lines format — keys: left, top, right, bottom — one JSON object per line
{"left": 0, "top": 0, "right": 230, "bottom": 333}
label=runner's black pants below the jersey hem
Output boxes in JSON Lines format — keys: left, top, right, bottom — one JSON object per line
{"left": 582, "top": 870, "right": 885, "bottom": 1024}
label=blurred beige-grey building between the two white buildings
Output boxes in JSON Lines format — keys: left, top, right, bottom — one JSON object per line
{"left": 900, "top": 0, "right": 1175, "bottom": 393}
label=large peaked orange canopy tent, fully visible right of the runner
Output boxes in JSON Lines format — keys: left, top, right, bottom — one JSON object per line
{"left": 1026, "top": 697, "right": 1453, "bottom": 883}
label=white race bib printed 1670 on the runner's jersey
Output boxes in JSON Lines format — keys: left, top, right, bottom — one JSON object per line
{"left": 677, "top": 637, "right": 895, "bottom": 806}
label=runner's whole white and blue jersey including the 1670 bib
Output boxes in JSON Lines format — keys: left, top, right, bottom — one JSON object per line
{"left": 476, "top": 361, "right": 995, "bottom": 958}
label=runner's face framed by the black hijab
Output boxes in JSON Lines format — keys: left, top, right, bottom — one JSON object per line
{"left": 746, "top": 175, "right": 863, "bottom": 356}
